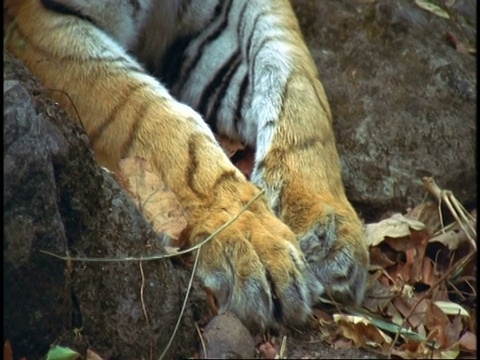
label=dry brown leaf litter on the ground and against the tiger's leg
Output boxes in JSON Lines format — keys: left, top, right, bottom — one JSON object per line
{"left": 10, "top": 140, "right": 477, "bottom": 359}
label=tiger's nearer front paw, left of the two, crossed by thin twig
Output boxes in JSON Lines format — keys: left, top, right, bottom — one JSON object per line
{"left": 183, "top": 195, "right": 323, "bottom": 330}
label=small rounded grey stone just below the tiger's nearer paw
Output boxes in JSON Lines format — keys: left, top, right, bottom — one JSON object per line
{"left": 200, "top": 313, "right": 255, "bottom": 359}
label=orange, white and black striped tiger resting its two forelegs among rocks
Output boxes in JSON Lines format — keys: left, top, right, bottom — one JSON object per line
{"left": 4, "top": 0, "right": 369, "bottom": 329}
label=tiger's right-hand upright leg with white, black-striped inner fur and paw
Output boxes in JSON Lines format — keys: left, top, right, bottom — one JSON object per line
{"left": 178, "top": 0, "right": 368, "bottom": 303}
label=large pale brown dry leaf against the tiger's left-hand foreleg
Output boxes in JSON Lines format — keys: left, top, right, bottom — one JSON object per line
{"left": 115, "top": 157, "right": 187, "bottom": 239}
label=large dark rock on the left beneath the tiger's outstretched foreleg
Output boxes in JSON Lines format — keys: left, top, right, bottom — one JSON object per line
{"left": 3, "top": 54, "right": 197, "bottom": 359}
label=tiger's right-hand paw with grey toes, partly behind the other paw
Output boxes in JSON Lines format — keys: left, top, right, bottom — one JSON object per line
{"left": 284, "top": 195, "right": 369, "bottom": 304}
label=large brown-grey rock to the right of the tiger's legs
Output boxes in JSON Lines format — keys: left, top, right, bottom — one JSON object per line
{"left": 293, "top": 0, "right": 477, "bottom": 220}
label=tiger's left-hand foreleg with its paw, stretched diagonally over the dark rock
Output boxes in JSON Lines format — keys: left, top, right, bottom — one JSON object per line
{"left": 7, "top": 0, "right": 321, "bottom": 328}
